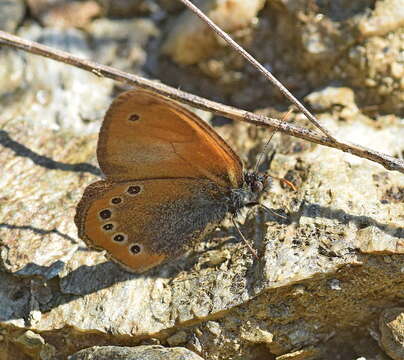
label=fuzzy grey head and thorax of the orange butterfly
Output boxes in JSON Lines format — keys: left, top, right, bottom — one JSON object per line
{"left": 229, "top": 171, "right": 272, "bottom": 215}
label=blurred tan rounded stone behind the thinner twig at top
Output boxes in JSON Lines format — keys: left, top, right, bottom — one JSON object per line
{"left": 162, "top": 0, "right": 265, "bottom": 65}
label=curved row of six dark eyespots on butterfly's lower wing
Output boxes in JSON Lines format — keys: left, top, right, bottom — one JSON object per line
{"left": 98, "top": 185, "right": 143, "bottom": 254}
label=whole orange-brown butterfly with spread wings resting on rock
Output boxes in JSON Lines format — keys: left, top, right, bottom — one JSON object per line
{"left": 74, "top": 90, "right": 271, "bottom": 273}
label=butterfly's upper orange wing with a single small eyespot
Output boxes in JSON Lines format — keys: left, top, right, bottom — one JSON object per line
{"left": 97, "top": 90, "right": 243, "bottom": 188}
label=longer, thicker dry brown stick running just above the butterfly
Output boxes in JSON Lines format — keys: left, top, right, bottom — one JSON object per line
{"left": 0, "top": 31, "right": 404, "bottom": 173}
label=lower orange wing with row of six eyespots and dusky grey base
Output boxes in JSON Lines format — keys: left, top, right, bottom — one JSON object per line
{"left": 75, "top": 179, "right": 228, "bottom": 272}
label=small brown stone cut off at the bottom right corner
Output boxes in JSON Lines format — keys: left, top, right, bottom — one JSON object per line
{"left": 379, "top": 307, "right": 404, "bottom": 360}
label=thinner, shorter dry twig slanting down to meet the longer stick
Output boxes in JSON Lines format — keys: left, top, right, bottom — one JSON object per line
{"left": 180, "top": 0, "right": 336, "bottom": 141}
